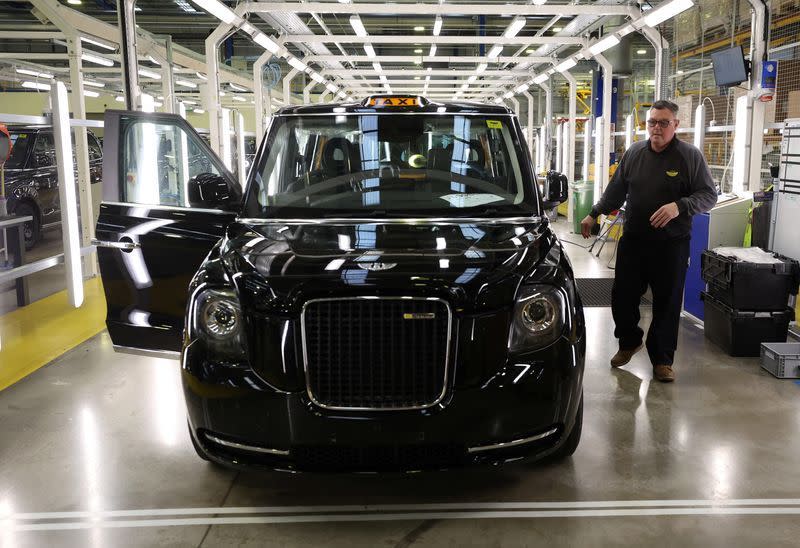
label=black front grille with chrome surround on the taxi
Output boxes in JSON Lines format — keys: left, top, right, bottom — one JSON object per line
{"left": 303, "top": 298, "right": 451, "bottom": 409}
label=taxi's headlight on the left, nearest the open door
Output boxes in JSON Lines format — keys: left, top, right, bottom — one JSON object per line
{"left": 189, "top": 289, "right": 246, "bottom": 359}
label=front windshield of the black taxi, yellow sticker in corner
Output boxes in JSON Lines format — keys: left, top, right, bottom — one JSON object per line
{"left": 243, "top": 113, "right": 538, "bottom": 218}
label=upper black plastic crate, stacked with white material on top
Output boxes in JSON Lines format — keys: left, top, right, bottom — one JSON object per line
{"left": 700, "top": 249, "right": 800, "bottom": 312}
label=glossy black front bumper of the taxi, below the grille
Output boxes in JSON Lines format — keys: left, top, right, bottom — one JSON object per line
{"left": 182, "top": 338, "right": 585, "bottom": 471}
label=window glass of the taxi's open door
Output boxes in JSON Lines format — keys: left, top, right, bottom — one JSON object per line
{"left": 120, "top": 120, "right": 227, "bottom": 207}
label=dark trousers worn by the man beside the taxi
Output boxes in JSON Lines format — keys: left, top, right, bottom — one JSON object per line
{"left": 611, "top": 236, "right": 689, "bottom": 365}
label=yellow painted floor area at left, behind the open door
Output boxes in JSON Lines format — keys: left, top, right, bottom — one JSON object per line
{"left": 0, "top": 277, "right": 106, "bottom": 390}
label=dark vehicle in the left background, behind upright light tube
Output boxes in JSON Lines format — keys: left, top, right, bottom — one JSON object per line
{"left": 5, "top": 126, "right": 103, "bottom": 249}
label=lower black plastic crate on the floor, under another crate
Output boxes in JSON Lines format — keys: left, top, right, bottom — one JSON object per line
{"left": 700, "top": 291, "right": 794, "bottom": 357}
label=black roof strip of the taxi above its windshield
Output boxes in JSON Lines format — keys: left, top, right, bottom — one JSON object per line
{"left": 273, "top": 95, "right": 515, "bottom": 116}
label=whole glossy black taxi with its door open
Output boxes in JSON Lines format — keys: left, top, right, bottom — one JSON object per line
{"left": 96, "top": 96, "right": 585, "bottom": 471}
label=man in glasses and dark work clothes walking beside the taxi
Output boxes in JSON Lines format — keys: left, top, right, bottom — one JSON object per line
{"left": 581, "top": 101, "right": 717, "bottom": 382}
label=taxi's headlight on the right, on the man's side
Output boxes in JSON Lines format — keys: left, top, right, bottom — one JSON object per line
{"left": 508, "top": 284, "right": 566, "bottom": 352}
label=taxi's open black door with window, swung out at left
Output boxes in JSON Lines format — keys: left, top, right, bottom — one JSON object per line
{"left": 94, "top": 110, "right": 242, "bottom": 357}
